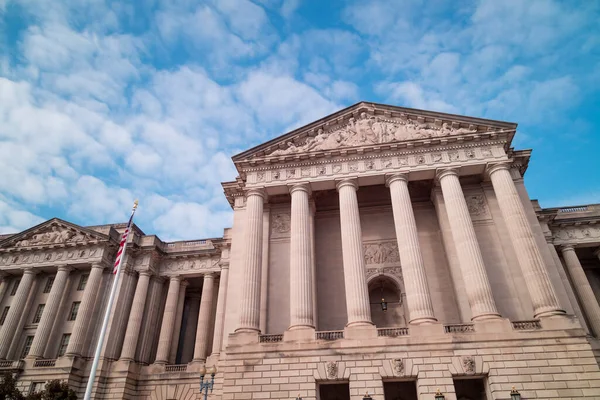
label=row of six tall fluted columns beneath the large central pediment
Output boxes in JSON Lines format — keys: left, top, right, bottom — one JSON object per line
{"left": 236, "top": 163, "right": 568, "bottom": 332}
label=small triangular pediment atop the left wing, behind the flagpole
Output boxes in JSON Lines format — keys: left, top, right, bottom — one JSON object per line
{"left": 0, "top": 218, "right": 109, "bottom": 248}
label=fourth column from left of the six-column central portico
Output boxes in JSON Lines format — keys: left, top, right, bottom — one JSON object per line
{"left": 386, "top": 174, "right": 437, "bottom": 324}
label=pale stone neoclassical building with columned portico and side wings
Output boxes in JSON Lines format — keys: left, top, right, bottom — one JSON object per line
{"left": 0, "top": 103, "right": 600, "bottom": 400}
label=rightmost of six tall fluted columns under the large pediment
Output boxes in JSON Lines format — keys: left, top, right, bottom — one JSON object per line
{"left": 487, "top": 163, "right": 565, "bottom": 318}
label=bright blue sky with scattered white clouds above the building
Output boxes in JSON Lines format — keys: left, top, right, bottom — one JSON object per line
{"left": 0, "top": 0, "right": 600, "bottom": 240}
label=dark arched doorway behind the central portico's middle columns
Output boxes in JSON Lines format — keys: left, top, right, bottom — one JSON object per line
{"left": 369, "top": 275, "right": 406, "bottom": 328}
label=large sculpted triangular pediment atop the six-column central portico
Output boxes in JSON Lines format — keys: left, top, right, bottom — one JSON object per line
{"left": 233, "top": 102, "right": 517, "bottom": 163}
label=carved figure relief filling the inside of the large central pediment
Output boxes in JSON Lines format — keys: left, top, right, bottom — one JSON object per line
{"left": 270, "top": 112, "right": 477, "bottom": 156}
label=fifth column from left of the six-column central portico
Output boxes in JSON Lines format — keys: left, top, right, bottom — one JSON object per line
{"left": 436, "top": 168, "right": 500, "bottom": 321}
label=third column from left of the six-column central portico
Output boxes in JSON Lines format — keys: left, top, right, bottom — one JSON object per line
{"left": 336, "top": 179, "right": 373, "bottom": 326}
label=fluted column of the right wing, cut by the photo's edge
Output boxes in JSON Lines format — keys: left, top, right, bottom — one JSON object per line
{"left": 561, "top": 245, "right": 600, "bottom": 337}
